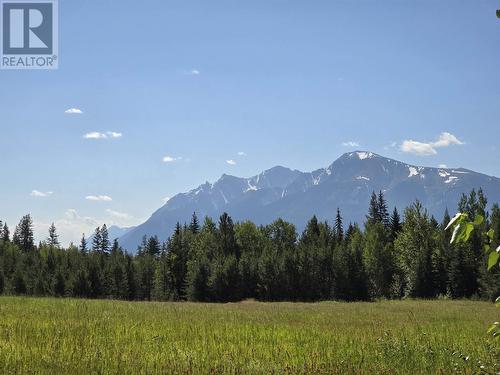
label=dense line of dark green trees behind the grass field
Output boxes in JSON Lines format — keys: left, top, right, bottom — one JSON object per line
{"left": 0, "top": 189, "right": 500, "bottom": 302}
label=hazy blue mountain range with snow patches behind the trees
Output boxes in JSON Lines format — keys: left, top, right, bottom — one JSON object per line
{"left": 117, "top": 151, "right": 500, "bottom": 251}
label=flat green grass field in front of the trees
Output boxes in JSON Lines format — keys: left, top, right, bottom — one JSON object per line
{"left": 0, "top": 297, "right": 500, "bottom": 374}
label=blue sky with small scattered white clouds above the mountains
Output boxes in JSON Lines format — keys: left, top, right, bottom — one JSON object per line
{"left": 0, "top": 0, "right": 500, "bottom": 245}
